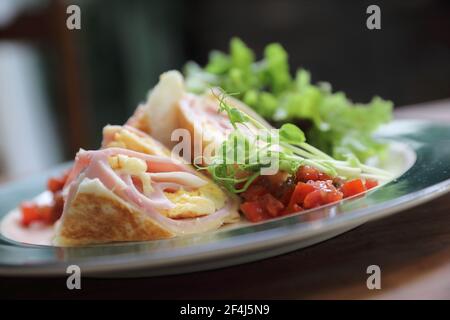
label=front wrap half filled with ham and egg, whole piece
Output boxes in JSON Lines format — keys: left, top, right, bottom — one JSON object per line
{"left": 54, "top": 126, "right": 239, "bottom": 246}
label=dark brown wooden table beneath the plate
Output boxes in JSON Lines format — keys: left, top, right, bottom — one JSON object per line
{"left": 0, "top": 101, "right": 450, "bottom": 299}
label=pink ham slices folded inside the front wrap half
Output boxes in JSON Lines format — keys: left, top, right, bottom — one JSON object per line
{"left": 63, "top": 148, "right": 237, "bottom": 235}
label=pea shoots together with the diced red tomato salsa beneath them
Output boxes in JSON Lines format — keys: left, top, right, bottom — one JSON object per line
{"left": 206, "top": 92, "right": 392, "bottom": 222}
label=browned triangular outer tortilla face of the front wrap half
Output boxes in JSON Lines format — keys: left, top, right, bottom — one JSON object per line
{"left": 53, "top": 178, "right": 175, "bottom": 246}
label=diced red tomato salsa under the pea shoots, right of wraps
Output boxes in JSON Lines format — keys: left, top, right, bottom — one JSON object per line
{"left": 240, "top": 166, "right": 378, "bottom": 222}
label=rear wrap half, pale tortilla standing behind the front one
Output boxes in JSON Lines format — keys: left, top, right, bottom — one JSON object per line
{"left": 127, "top": 71, "right": 272, "bottom": 164}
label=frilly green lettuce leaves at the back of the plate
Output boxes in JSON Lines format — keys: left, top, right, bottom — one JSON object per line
{"left": 184, "top": 38, "right": 392, "bottom": 162}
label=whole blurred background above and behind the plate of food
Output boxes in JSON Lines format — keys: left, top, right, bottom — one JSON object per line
{"left": 0, "top": 0, "right": 450, "bottom": 182}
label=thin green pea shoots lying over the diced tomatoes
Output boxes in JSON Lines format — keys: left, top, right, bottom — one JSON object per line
{"left": 206, "top": 92, "right": 392, "bottom": 193}
